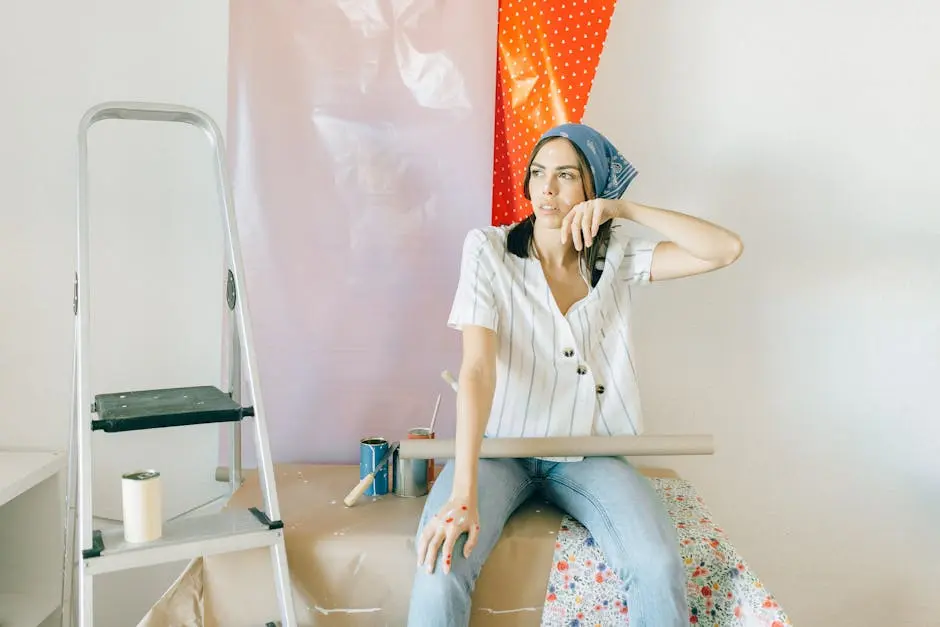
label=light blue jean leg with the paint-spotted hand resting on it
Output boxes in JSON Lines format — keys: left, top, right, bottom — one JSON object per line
{"left": 408, "top": 459, "right": 534, "bottom": 627}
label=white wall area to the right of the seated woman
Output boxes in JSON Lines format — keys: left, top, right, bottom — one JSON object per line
{"left": 585, "top": 0, "right": 940, "bottom": 627}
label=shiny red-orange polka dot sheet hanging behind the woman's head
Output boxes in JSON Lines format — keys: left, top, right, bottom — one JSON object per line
{"left": 493, "top": 0, "right": 616, "bottom": 226}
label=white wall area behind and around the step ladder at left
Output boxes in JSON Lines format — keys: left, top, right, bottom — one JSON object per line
{"left": 0, "top": 0, "right": 228, "bottom": 627}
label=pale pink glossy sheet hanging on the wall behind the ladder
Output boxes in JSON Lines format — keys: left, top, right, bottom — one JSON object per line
{"left": 221, "top": 0, "right": 498, "bottom": 466}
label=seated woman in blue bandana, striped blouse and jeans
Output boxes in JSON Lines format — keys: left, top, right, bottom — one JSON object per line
{"left": 408, "top": 124, "right": 742, "bottom": 627}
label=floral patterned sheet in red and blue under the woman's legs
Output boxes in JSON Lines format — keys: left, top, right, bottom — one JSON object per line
{"left": 542, "top": 478, "right": 791, "bottom": 627}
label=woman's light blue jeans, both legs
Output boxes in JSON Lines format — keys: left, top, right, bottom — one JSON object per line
{"left": 408, "top": 457, "right": 689, "bottom": 627}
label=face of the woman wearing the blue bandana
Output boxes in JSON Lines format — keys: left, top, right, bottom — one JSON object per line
{"left": 529, "top": 137, "right": 587, "bottom": 229}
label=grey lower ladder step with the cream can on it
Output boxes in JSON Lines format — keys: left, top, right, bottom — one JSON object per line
{"left": 84, "top": 509, "right": 284, "bottom": 575}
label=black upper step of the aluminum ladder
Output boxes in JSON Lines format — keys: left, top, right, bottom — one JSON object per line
{"left": 91, "top": 385, "right": 254, "bottom": 433}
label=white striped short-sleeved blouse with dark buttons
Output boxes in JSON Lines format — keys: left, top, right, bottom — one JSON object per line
{"left": 448, "top": 220, "right": 656, "bottom": 461}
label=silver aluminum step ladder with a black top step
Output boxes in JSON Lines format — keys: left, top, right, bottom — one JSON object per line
{"left": 62, "top": 102, "right": 297, "bottom": 627}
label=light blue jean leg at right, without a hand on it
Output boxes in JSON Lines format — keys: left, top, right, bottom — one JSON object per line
{"left": 545, "top": 457, "right": 689, "bottom": 627}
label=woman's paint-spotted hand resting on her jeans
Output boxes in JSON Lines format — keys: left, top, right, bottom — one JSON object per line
{"left": 416, "top": 495, "right": 480, "bottom": 573}
